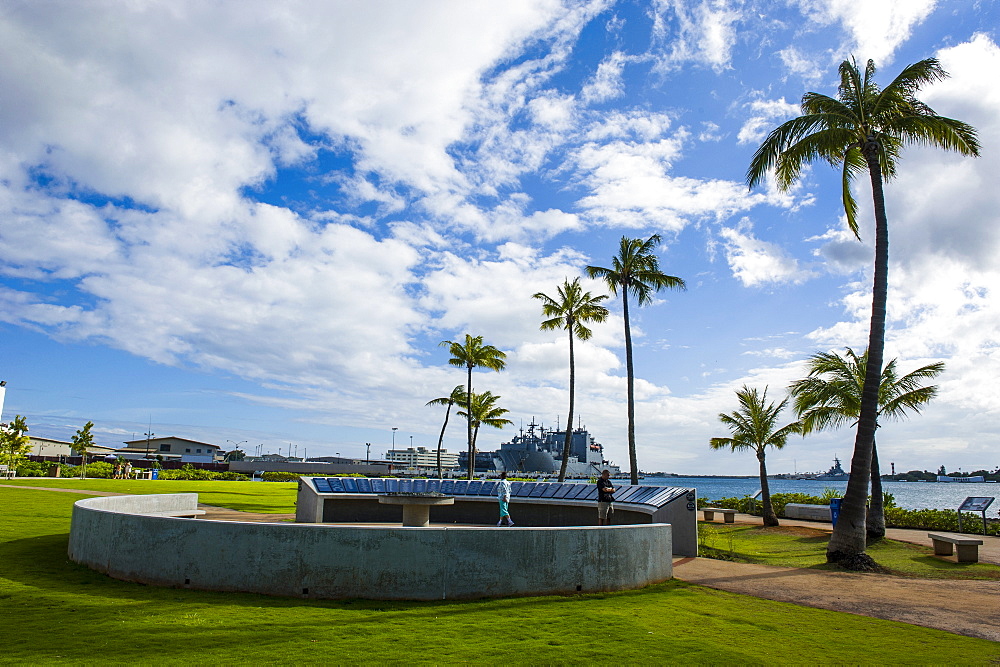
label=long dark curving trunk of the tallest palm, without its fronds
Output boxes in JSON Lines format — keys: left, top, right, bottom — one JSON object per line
{"left": 826, "top": 136, "right": 889, "bottom": 569}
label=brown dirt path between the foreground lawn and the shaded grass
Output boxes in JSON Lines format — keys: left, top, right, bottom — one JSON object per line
{"left": 674, "top": 558, "right": 1000, "bottom": 641}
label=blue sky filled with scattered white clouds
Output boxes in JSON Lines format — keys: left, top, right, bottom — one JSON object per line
{"left": 0, "top": 0, "right": 1000, "bottom": 475}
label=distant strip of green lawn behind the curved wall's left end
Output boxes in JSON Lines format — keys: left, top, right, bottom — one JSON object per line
{"left": 4, "top": 477, "right": 298, "bottom": 514}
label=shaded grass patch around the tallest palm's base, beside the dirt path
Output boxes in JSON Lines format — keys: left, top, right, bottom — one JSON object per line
{"left": 698, "top": 522, "right": 1000, "bottom": 579}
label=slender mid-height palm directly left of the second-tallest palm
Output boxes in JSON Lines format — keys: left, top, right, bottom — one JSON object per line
{"left": 533, "top": 278, "right": 608, "bottom": 482}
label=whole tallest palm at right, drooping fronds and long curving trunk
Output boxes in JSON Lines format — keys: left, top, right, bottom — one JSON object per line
{"left": 747, "top": 58, "right": 979, "bottom": 568}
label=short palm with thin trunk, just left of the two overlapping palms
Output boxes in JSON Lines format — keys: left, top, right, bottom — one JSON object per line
{"left": 709, "top": 385, "right": 802, "bottom": 526}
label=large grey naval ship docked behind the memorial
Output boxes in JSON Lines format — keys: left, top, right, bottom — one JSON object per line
{"left": 458, "top": 418, "right": 621, "bottom": 477}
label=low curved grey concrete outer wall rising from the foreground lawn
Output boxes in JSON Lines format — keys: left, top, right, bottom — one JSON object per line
{"left": 69, "top": 494, "right": 672, "bottom": 600}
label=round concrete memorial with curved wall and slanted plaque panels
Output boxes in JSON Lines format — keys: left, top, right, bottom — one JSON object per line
{"left": 69, "top": 477, "right": 698, "bottom": 600}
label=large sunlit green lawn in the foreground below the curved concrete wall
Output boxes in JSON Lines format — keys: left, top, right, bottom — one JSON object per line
{"left": 0, "top": 480, "right": 1000, "bottom": 665}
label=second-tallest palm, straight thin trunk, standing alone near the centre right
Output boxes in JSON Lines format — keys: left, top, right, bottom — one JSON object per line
{"left": 587, "top": 234, "right": 686, "bottom": 484}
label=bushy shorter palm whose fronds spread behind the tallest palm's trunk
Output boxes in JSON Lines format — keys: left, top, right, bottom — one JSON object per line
{"left": 789, "top": 348, "right": 944, "bottom": 541}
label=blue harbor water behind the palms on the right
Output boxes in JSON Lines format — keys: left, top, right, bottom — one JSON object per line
{"left": 641, "top": 477, "right": 1000, "bottom": 517}
